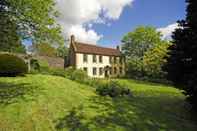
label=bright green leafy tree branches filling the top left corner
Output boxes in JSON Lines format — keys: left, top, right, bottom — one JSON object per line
{"left": 0, "top": 0, "right": 63, "bottom": 48}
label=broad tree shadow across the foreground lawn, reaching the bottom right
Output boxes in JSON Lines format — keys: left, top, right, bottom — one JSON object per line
{"left": 56, "top": 96, "right": 197, "bottom": 131}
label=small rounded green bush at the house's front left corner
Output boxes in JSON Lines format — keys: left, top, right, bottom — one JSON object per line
{"left": 70, "top": 70, "right": 88, "bottom": 83}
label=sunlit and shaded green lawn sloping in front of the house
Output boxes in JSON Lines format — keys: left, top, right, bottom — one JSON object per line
{"left": 0, "top": 75, "right": 197, "bottom": 131}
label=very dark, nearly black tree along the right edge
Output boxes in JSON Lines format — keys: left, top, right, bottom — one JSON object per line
{"left": 163, "top": 0, "right": 197, "bottom": 107}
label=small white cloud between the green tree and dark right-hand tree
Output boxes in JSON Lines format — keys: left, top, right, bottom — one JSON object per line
{"left": 157, "top": 23, "right": 178, "bottom": 40}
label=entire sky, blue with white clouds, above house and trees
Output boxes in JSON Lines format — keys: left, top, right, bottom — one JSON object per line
{"left": 26, "top": 0, "right": 186, "bottom": 47}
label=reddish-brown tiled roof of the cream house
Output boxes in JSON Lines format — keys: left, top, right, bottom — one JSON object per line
{"left": 74, "top": 42, "right": 121, "bottom": 56}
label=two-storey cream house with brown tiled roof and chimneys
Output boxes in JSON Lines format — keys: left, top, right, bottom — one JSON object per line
{"left": 68, "top": 35, "right": 125, "bottom": 78}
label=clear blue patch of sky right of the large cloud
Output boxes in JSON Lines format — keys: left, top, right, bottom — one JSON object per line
{"left": 93, "top": 0, "right": 186, "bottom": 46}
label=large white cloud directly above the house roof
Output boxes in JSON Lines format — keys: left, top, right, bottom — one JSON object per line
{"left": 56, "top": 0, "right": 134, "bottom": 43}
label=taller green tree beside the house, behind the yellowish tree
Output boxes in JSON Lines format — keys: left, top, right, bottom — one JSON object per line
{"left": 122, "top": 26, "right": 163, "bottom": 77}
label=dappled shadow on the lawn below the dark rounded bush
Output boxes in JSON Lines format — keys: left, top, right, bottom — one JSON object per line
{"left": 0, "top": 82, "right": 39, "bottom": 106}
